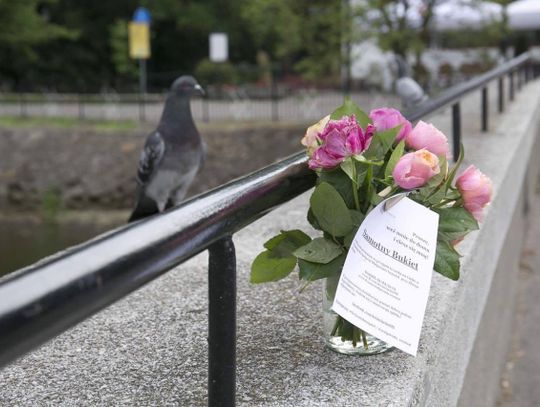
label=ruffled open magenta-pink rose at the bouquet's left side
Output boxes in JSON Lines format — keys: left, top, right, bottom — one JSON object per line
{"left": 308, "top": 115, "right": 375, "bottom": 170}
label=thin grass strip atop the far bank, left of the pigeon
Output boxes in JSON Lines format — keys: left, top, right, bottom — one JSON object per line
{"left": 0, "top": 116, "right": 139, "bottom": 131}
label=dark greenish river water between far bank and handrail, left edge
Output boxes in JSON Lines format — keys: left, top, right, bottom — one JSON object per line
{"left": 0, "top": 213, "right": 126, "bottom": 277}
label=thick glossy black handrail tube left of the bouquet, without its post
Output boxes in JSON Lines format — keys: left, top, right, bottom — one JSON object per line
{"left": 0, "top": 153, "right": 315, "bottom": 366}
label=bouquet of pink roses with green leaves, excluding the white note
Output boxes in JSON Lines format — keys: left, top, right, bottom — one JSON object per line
{"left": 251, "top": 99, "right": 492, "bottom": 354}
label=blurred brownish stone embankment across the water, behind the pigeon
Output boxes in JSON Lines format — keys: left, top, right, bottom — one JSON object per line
{"left": 0, "top": 122, "right": 306, "bottom": 213}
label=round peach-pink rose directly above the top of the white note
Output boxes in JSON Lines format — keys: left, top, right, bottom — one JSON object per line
{"left": 392, "top": 149, "right": 440, "bottom": 189}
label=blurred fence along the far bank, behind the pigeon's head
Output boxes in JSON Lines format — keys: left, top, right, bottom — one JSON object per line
{"left": 0, "top": 88, "right": 400, "bottom": 123}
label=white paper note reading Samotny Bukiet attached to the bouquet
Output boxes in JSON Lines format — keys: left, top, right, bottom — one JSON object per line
{"left": 332, "top": 197, "right": 439, "bottom": 356}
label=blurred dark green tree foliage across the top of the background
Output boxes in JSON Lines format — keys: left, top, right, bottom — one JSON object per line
{"left": 0, "top": 0, "right": 524, "bottom": 92}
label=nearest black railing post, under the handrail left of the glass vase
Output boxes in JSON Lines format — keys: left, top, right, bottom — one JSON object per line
{"left": 208, "top": 236, "right": 236, "bottom": 407}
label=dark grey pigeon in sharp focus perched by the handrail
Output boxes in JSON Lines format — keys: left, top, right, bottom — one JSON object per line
{"left": 129, "top": 76, "right": 205, "bottom": 222}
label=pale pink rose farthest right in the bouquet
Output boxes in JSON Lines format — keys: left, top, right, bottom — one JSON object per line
{"left": 456, "top": 165, "right": 493, "bottom": 222}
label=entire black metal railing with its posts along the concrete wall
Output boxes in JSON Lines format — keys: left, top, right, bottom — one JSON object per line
{"left": 0, "top": 54, "right": 532, "bottom": 406}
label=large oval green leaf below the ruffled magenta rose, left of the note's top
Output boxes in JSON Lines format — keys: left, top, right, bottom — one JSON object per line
{"left": 310, "top": 182, "right": 352, "bottom": 237}
